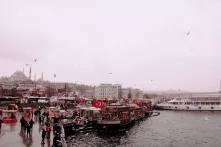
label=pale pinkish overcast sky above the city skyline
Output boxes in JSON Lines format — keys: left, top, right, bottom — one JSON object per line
{"left": 0, "top": 0, "right": 221, "bottom": 91}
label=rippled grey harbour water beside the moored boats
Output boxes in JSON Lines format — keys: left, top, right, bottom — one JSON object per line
{"left": 67, "top": 111, "right": 221, "bottom": 147}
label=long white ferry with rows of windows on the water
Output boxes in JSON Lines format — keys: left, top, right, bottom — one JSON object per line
{"left": 157, "top": 95, "right": 221, "bottom": 111}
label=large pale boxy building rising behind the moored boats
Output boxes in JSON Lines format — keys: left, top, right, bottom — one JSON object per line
{"left": 95, "top": 84, "right": 121, "bottom": 99}
